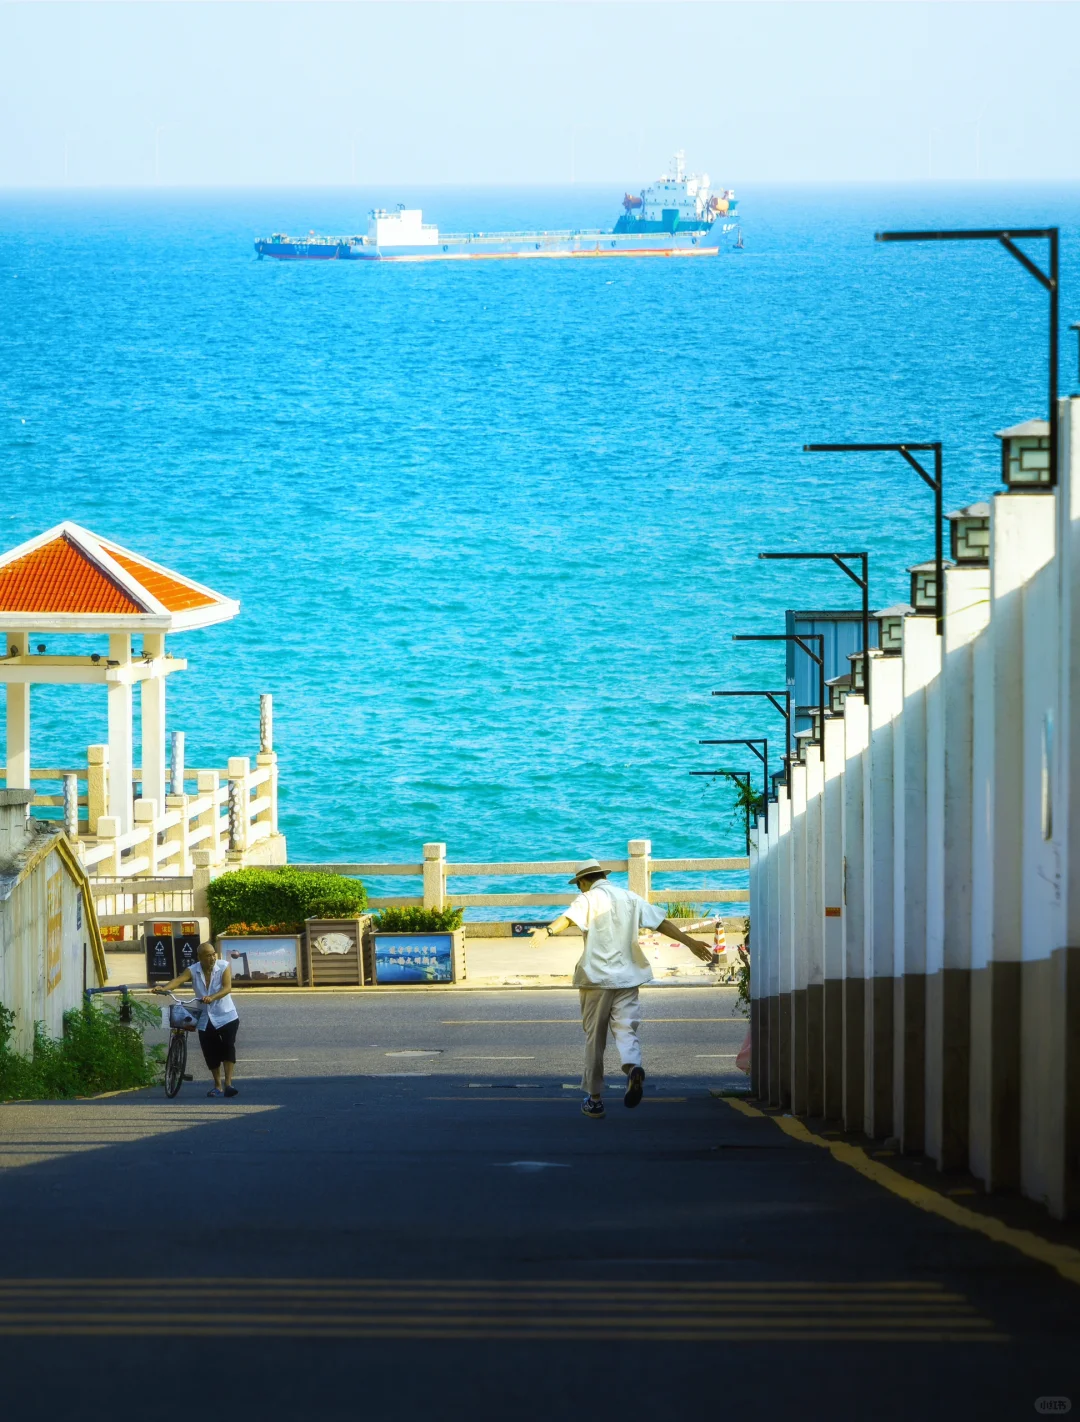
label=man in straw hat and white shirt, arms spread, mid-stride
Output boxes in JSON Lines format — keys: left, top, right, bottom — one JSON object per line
{"left": 532, "top": 859, "right": 713, "bottom": 1121}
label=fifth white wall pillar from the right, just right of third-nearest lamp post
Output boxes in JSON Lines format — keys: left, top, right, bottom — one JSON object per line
{"left": 862, "top": 653, "right": 904, "bottom": 1139}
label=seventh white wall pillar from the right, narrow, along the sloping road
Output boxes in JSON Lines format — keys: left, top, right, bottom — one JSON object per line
{"left": 821, "top": 715, "right": 844, "bottom": 1121}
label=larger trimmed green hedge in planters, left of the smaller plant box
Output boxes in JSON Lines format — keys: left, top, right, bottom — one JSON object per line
{"left": 208, "top": 865, "right": 367, "bottom": 933}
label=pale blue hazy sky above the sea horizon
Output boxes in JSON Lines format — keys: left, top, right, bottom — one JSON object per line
{"left": 0, "top": 0, "right": 1080, "bottom": 188}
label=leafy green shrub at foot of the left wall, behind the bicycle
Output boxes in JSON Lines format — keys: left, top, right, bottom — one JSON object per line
{"left": 0, "top": 1001, "right": 161, "bottom": 1101}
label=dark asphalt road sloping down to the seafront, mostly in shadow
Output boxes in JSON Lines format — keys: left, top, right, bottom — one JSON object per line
{"left": 0, "top": 988, "right": 1080, "bottom": 1422}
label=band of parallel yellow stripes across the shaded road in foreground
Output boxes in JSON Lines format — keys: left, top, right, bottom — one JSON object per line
{"left": 0, "top": 1278, "right": 1003, "bottom": 1342}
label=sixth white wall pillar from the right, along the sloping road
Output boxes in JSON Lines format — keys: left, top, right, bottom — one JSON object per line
{"left": 841, "top": 694, "right": 869, "bottom": 1130}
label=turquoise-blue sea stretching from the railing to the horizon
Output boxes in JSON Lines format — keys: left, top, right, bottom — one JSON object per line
{"left": 0, "top": 185, "right": 1080, "bottom": 898}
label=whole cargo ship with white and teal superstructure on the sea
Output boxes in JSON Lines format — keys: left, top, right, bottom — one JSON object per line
{"left": 255, "top": 152, "right": 743, "bottom": 262}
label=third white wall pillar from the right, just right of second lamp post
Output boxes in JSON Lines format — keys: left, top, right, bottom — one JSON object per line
{"left": 925, "top": 567, "right": 990, "bottom": 1170}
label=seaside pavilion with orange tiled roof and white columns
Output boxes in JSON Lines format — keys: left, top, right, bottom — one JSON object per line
{"left": 0, "top": 522, "right": 240, "bottom": 833}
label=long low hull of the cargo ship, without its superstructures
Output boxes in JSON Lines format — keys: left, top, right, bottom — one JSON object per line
{"left": 255, "top": 232, "right": 727, "bottom": 262}
